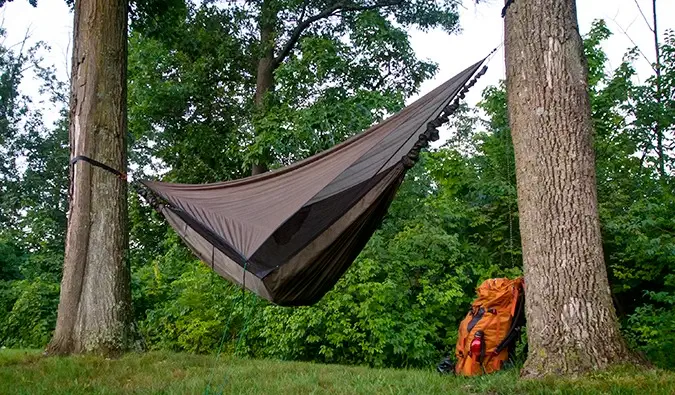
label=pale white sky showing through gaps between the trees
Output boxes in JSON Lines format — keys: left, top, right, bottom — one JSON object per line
{"left": 0, "top": 0, "right": 675, "bottom": 135}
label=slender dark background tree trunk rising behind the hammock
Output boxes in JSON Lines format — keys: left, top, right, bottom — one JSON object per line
{"left": 251, "top": 1, "right": 277, "bottom": 175}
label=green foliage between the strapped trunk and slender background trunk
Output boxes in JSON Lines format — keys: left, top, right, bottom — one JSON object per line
{"left": 128, "top": 6, "right": 253, "bottom": 182}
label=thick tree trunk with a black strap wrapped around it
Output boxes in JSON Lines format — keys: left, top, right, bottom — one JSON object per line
{"left": 47, "top": 0, "right": 131, "bottom": 355}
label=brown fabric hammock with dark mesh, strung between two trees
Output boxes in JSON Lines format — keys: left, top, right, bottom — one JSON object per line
{"left": 141, "top": 60, "right": 486, "bottom": 306}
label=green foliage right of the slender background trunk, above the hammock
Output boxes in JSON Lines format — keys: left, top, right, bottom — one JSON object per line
{"left": 246, "top": 1, "right": 444, "bottom": 167}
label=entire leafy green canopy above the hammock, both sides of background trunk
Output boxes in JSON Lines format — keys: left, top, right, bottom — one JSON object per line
{"left": 129, "top": 0, "right": 457, "bottom": 182}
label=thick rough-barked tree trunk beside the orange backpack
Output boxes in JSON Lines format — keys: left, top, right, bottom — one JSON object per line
{"left": 505, "top": 0, "right": 635, "bottom": 377}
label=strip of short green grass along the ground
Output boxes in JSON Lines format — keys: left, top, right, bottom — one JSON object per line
{"left": 0, "top": 350, "right": 675, "bottom": 395}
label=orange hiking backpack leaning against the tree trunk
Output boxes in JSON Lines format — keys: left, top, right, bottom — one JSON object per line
{"left": 455, "top": 278, "right": 524, "bottom": 376}
